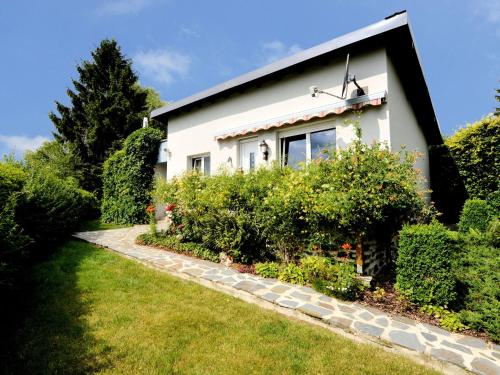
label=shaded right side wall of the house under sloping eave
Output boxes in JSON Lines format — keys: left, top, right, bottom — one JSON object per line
{"left": 387, "top": 53, "right": 430, "bottom": 189}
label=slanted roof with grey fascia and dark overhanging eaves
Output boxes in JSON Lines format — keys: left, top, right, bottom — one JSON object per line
{"left": 151, "top": 11, "right": 442, "bottom": 144}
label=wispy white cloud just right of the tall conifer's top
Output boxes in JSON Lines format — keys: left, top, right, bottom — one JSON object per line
{"left": 134, "top": 49, "right": 191, "bottom": 85}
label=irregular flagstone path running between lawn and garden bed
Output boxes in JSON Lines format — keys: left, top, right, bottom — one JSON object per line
{"left": 75, "top": 226, "right": 500, "bottom": 375}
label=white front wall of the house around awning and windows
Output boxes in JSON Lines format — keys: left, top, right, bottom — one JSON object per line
{"left": 167, "top": 49, "right": 390, "bottom": 178}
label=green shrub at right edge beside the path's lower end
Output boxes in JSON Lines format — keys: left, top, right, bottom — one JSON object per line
{"left": 454, "top": 233, "right": 500, "bottom": 341}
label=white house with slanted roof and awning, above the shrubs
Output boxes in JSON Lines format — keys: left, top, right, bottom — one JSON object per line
{"left": 151, "top": 12, "right": 442, "bottom": 191}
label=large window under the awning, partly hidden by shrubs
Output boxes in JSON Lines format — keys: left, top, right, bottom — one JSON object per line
{"left": 281, "top": 128, "right": 336, "bottom": 168}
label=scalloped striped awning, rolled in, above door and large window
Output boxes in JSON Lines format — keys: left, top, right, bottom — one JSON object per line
{"left": 215, "top": 91, "right": 387, "bottom": 141}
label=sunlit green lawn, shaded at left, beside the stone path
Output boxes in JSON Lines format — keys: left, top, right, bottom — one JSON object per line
{"left": 0, "top": 241, "right": 442, "bottom": 375}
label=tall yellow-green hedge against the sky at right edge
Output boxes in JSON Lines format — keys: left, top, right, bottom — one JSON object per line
{"left": 446, "top": 116, "right": 500, "bottom": 199}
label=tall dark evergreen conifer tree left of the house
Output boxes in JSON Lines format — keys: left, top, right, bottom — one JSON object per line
{"left": 49, "top": 39, "right": 148, "bottom": 196}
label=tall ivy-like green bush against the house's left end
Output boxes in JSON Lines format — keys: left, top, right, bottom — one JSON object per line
{"left": 101, "top": 128, "right": 162, "bottom": 224}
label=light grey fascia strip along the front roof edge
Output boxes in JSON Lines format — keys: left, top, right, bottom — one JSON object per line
{"left": 151, "top": 12, "right": 408, "bottom": 120}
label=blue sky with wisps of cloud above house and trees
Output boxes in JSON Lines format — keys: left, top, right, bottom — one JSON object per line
{"left": 0, "top": 0, "right": 500, "bottom": 155}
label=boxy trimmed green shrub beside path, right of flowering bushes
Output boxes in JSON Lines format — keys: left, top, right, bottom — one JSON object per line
{"left": 396, "top": 221, "right": 456, "bottom": 306}
